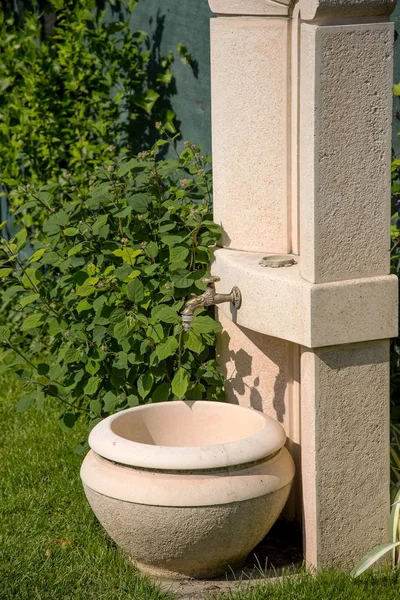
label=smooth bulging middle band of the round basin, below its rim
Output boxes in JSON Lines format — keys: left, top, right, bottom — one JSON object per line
{"left": 80, "top": 448, "right": 294, "bottom": 508}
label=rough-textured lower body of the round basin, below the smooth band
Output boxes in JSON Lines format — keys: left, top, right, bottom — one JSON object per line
{"left": 84, "top": 484, "right": 290, "bottom": 579}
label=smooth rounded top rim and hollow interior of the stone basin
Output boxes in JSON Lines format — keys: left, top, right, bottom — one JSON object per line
{"left": 89, "top": 400, "right": 286, "bottom": 471}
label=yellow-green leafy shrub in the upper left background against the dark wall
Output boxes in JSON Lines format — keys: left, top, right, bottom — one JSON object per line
{"left": 0, "top": 0, "right": 175, "bottom": 227}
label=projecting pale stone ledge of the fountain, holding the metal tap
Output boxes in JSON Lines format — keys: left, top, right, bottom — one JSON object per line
{"left": 212, "top": 248, "right": 398, "bottom": 348}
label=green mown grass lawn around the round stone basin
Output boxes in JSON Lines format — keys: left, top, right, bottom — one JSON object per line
{"left": 0, "top": 376, "right": 400, "bottom": 600}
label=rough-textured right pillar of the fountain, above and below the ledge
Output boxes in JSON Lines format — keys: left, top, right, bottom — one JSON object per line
{"left": 298, "top": 1, "right": 395, "bottom": 566}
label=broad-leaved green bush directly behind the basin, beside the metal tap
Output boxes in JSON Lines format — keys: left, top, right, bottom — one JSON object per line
{"left": 0, "top": 135, "right": 223, "bottom": 440}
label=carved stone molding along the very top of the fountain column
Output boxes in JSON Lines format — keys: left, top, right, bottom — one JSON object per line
{"left": 209, "top": 0, "right": 396, "bottom": 21}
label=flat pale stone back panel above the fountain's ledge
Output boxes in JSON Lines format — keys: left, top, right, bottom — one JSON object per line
{"left": 211, "top": 17, "right": 288, "bottom": 252}
